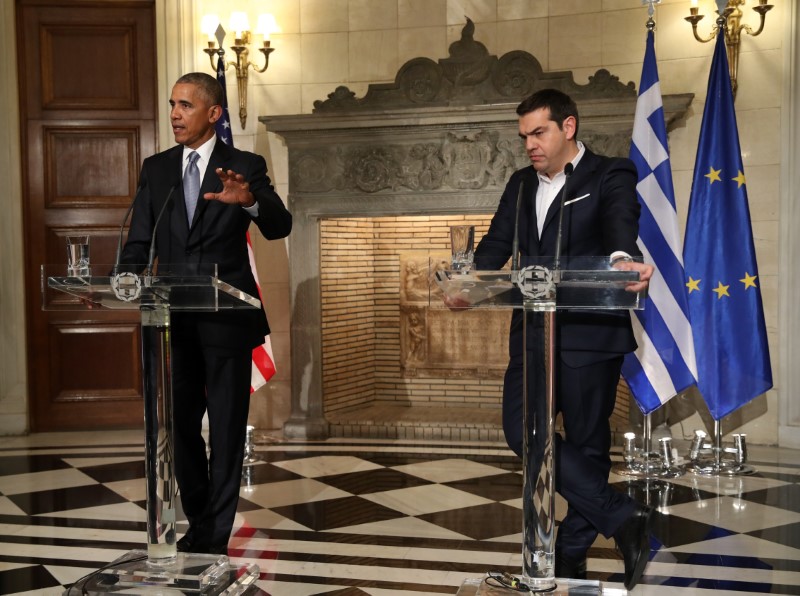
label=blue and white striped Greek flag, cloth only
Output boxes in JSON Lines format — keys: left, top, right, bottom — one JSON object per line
{"left": 622, "top": 31, "right": 697, "bottom": 414}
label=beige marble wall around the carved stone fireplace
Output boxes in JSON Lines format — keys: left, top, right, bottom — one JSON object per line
{"left": 0, "top": 0, "right": 800, "bottom": 443}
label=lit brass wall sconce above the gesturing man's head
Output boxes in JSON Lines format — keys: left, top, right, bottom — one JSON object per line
{"left": 200, "top": 12, "right": 280, "bottom": 129}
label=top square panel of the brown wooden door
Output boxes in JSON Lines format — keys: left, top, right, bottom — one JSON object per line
{"left": 17, "top": 0, "right": 156, "bottom": 120}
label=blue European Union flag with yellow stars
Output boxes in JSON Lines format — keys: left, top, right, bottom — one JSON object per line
{"left": 683, "top": 31, "right": 772, "bottom": 420}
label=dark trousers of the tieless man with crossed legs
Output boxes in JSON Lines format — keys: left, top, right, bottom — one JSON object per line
{"left": 503, "top": 342, "right": 635, "bottom": 559}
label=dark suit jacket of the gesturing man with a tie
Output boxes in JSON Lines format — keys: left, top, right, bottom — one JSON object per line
{"left": 121, "top": 139, "right": 292, "bottom": 349}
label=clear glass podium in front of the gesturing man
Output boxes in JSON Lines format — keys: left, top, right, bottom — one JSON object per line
{"left": 41, "top": 264, "right": 261, "bottom": 594}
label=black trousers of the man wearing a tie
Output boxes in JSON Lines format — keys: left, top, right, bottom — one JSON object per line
{"left": 172, "top": 326, "right": 252, "bottom": 546}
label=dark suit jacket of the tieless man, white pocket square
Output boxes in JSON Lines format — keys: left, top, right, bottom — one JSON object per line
{"left": 475, "top": 149, "right": 641, "bottom": 366}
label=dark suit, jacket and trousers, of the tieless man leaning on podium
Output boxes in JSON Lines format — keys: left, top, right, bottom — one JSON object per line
{"left": 475, "top": 149, "right": 641, "bottom": 559}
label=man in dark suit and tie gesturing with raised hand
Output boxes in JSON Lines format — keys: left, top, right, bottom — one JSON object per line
{"left": 122, "top": 73, "right": 292, "bottom": 554}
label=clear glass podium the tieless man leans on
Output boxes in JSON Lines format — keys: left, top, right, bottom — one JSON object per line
{"left": 430, "top": 257, "right": 644, "bottom": 596}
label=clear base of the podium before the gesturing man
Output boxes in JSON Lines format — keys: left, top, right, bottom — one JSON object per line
{"left": 72, "top": 550, "right": 260, "bottom": 596}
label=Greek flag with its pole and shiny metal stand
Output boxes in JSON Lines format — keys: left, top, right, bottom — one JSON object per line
{"left": 614, "top": 0, "right": 694, "bottom": 486}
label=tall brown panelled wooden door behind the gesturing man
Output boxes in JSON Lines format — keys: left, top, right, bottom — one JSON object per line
{"left": 16, "top": 0, "right": 157, "bottom": 431}
